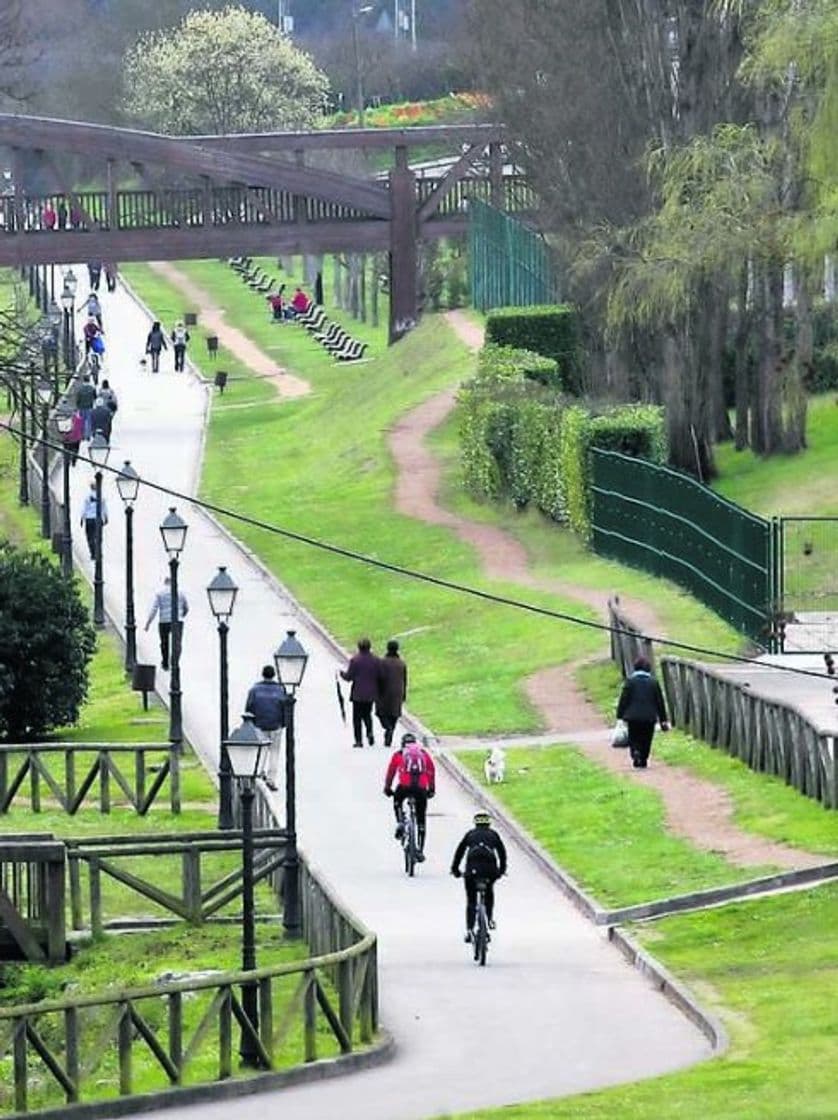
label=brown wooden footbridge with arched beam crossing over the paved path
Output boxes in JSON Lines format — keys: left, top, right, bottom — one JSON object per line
{"left": 0, "top": 114, "right": 534, "bottom": 338}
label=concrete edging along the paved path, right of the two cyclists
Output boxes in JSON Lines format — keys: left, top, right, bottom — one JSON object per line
{"left": 438, "top": 752, "right": 729, "bottom": 1057}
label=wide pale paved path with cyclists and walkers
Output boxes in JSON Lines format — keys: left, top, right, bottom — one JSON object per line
{"left": 73, "top": 277, "right": 709, "bottom": 1120}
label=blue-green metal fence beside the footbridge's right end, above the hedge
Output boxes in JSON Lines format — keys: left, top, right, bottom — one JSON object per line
{"left": 468, "top": 199, "right": 559, "bottom": 311}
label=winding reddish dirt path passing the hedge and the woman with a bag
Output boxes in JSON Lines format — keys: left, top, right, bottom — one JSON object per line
{"left": 398, "top": 311, "right": 823, "bottom": 868}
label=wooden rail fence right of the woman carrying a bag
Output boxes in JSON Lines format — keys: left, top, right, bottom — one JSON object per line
{"left": 661, "top": 657, "right": 838, "bottom": 809}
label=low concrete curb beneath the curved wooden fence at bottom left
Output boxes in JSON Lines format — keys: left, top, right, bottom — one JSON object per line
{"left": 9, "top": 1032, "right": 397, "bottom": 1120}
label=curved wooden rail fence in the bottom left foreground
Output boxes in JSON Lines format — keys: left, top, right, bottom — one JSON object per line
{"left": 0, "top": 860, "right": 378, "bottom": 1114}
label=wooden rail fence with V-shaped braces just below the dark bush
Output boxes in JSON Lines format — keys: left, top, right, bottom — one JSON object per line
{"left": 0, "top": 743, "right": 180, "bottom": 816}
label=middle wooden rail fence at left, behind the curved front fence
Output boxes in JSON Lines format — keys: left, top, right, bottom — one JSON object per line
{"left": 66, "top": 829, "right": 287, "bottom": 935}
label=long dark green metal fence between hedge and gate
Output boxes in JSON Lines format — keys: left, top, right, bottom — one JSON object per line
{"left": 592, "top": 450, "right": 778, "bottom": 648}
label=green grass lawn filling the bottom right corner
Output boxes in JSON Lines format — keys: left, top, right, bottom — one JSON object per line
{"left": 459, "top": 885, "right": 838, "bottom": 1120}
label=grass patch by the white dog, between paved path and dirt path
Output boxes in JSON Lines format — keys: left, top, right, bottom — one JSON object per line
{"left": 457, "top": 747, "right": 775, "bottom": 907}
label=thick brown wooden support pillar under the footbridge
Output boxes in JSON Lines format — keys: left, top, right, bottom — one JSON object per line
{"left": 390, "top": 147, "right": 419, "bottom": 345}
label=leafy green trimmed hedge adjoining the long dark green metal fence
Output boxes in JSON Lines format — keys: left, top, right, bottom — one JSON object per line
{"left": 459, "top": 346, "right": 668, "bottom": 541}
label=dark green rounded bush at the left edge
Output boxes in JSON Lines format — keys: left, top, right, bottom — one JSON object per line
{"left": 0, "top": 543, "right": 95, "bottom": 741}
